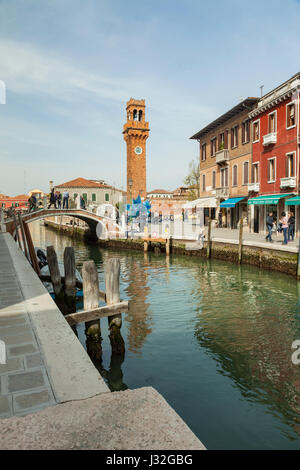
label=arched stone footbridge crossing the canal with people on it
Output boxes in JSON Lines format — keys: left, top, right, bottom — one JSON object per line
{"left": 4, "top": 209, "right": 121, "bottom": 239}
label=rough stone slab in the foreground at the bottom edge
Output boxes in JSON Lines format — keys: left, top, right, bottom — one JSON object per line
{"left": 0, "top": 387, "right": 205, "bottom": 450}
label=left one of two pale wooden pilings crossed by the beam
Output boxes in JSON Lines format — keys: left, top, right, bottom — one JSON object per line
{"left": 82, "top": 261, "right": 102, "bottom": 357}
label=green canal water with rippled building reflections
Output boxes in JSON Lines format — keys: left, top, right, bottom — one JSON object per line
{"left": 33, "top": 225, "right": 300, "bottom": 449}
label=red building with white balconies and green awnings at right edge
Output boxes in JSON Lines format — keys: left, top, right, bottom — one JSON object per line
{"left": 248, "top": 73, "right": 300, "bottom": 232}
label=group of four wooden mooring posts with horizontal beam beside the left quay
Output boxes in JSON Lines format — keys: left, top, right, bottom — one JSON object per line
{"left": 41, "top": 246, "right": 128, "bottom": 357}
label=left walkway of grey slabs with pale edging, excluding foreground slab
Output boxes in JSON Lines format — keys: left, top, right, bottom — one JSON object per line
{"left": 0, "top": 233, "right": 109, "bottom": 418}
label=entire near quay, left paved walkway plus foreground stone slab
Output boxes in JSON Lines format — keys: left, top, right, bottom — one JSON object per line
{"left": 0, "top": 232, "right": 204, "bottom": 450}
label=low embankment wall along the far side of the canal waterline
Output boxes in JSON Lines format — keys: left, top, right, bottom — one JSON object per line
{"left": 47, "top": 221, "right": 298, "bottom": 277}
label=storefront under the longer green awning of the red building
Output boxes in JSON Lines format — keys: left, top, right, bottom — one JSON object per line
{"left": 248, "top": 193, "right": 294, "bottom": 233}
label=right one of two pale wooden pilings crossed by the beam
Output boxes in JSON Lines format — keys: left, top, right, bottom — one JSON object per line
{"left": 105, "top": 258, "right": 125, "bottom": 355}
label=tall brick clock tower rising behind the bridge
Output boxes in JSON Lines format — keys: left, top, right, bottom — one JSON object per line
{"left": 123, "top": 98, "right": 149, "bottom": 203}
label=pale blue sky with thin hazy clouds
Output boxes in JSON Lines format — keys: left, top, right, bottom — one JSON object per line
{"left": 0, "top": 0, "right": 300, "bottom": 195}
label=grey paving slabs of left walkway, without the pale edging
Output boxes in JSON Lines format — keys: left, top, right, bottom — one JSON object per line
{"left": 0, "top": 234, "right": 55, "bottom": 418}
